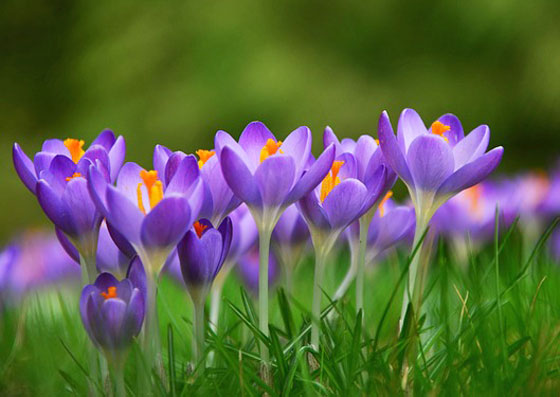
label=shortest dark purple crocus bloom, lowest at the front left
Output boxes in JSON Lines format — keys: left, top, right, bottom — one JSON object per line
{"left": 80, "top": 257, "right": 145, "bottom": 363}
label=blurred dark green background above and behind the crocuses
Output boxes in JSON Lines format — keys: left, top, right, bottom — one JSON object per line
{"left": 0, "top": 0, "right": 560, "bottom": 243}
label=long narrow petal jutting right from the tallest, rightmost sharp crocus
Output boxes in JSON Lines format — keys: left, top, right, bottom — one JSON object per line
{"left": 436, "top": 146, "right": 504, "bottom": 196}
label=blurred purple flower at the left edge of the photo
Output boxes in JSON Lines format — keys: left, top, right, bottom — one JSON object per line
{"left": 0, "top": 232, "right": 80, "bottom": 306}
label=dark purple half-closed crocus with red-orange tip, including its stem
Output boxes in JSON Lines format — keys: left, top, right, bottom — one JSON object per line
{"left": 177, "top": 217, "right": 232, "bottom": 361}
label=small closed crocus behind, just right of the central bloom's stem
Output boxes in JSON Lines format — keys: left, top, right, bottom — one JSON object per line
{"left": 272, "top": 204, "right": 310, "bottom": 291}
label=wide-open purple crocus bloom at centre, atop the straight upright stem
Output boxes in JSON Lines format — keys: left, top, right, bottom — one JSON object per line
{"left": 215, "top": 122, "right": 334, "bottom": 232}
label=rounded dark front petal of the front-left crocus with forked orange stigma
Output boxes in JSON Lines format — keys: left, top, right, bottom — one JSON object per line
{"left": 141, "top": 196, "right": 193, "bottom": 248}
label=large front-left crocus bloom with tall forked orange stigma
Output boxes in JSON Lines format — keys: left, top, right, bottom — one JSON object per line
{"left": 89, "top": 147, "right": 204, "bottom": 273}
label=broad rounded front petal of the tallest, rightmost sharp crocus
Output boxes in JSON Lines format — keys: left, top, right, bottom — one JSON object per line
{"left": 407, "top": 134, "right": 454, "bottom": 192}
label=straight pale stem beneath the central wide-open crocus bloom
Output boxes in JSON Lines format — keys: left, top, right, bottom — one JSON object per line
{"left": 259, "top": 228, "right": 272, "bottom": 364}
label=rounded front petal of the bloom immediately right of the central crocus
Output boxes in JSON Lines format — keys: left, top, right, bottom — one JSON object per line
{"left": 323, "top": 179, "right": 367, "bottom": 229}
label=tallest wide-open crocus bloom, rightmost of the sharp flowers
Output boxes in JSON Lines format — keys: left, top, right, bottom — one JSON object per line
{"left": 379, "top": 109, "right": 504, "bottom": 221}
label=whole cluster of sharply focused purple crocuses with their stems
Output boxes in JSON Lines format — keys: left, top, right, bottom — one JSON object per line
{"left": 7, "top": 109, "right": 503, "bottom": 384}
